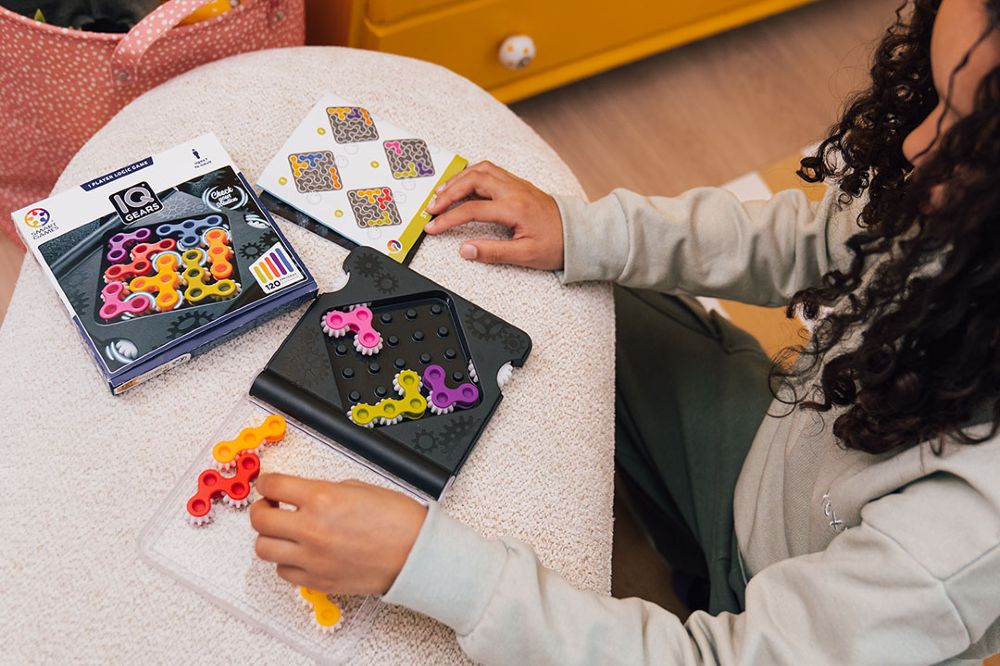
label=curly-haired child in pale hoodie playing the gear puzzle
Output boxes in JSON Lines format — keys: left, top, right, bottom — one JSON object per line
{"left": 251, "top": 0, "right": 1000, "bottom": 664}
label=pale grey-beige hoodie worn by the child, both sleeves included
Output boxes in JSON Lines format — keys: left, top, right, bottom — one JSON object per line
{"left": 385, "top": 188, "right": 1000, "bottom": 665}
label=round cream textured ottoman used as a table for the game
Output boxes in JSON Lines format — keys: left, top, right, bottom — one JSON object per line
{"left": 0, "top": 48, "right": 614, "bottom": 664}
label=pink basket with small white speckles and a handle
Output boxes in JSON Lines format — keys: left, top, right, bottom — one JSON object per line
{"left": 0, "top": 0, "right": 305, "bottom": 235}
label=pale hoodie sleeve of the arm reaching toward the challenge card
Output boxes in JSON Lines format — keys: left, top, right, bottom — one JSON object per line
{"left": 556, "top": 187, "right": 860, "bottom": 306}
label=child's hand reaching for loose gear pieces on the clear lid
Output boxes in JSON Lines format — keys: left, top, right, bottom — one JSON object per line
{"left": 250, "top": 474, "right": 427, "bottom": 594}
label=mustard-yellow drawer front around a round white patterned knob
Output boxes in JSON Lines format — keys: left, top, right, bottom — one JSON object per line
{"left": 359, "top": 0, "right": 776, "bottom": 89}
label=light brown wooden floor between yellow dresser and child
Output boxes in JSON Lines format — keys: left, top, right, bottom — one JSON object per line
{"left": 513, "top": 0, "right": 898, "bottom": 616}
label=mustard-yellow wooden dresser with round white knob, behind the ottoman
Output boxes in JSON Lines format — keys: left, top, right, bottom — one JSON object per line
{"left": 307, "top": 0, "right": 812, "bottom": 102}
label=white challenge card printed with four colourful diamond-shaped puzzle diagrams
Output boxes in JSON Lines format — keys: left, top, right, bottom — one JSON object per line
{"left": 257, "top": 94, "right": 468, "bottom": 263}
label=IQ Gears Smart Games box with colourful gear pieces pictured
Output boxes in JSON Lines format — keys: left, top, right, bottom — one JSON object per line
{"left": 12, "top": 134, "right": 316, "bottom": 393}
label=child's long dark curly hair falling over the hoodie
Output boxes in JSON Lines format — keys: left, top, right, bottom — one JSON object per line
{"left": 771, "top": 0, "right": 1000, "bottom": 453}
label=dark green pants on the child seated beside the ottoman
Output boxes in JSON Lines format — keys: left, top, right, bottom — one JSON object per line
{"left": 615, "top": 287, "right": 771, "bottom": 614}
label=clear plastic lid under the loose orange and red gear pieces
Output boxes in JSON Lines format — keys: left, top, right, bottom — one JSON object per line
{"left": 139, "top": 399, "right": 423, "bottom": 664}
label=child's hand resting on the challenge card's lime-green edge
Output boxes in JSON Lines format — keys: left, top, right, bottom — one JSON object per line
{"left": 424, "top": 162, "right": 563, "bottom": 270}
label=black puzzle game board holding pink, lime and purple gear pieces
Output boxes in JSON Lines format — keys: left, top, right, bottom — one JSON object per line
{"left": 250, "top": 247, "right": 531, "bottom": 498}
